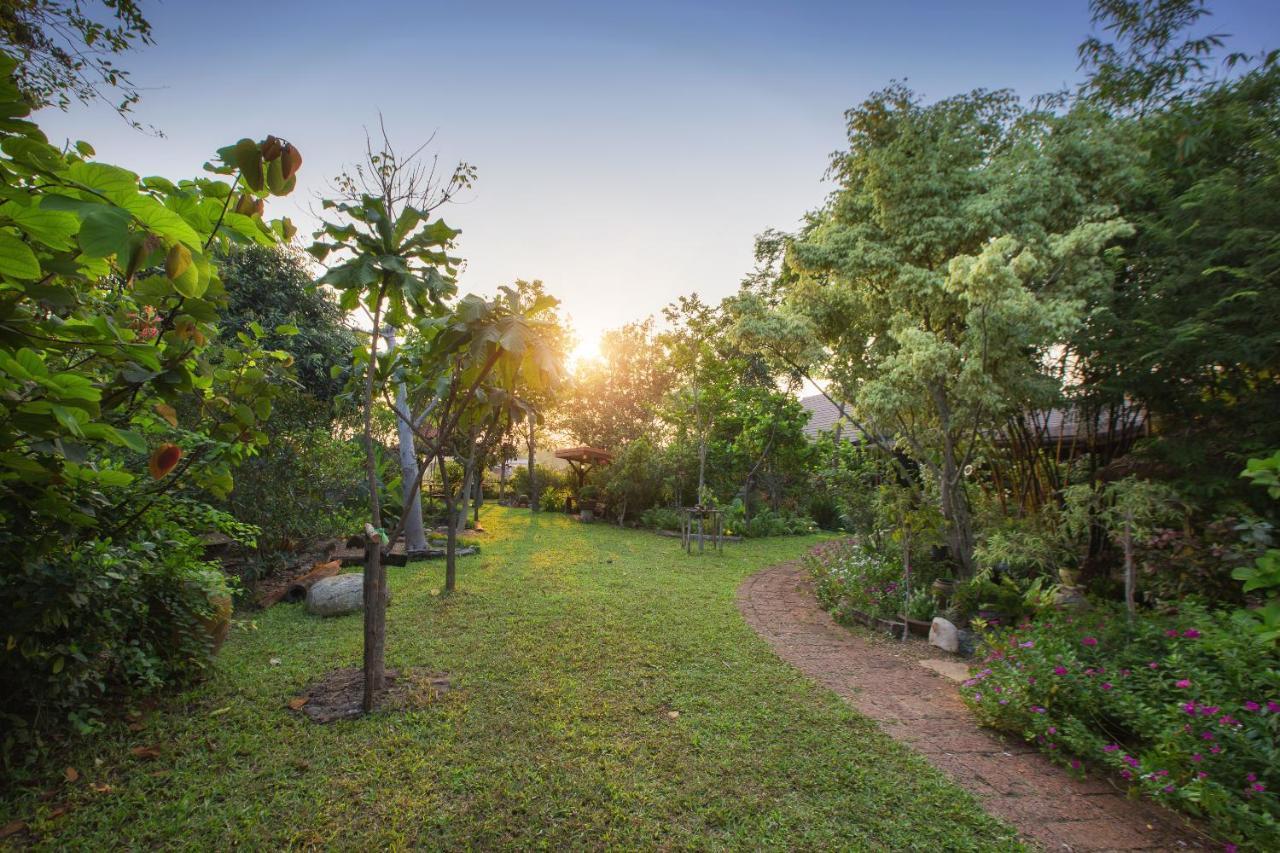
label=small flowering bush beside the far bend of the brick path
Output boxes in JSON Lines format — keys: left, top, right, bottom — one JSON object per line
{"left": 804, "top": 539, "right": 905, "bottom": 619}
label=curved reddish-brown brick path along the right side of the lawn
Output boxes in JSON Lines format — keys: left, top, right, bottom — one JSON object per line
{"left": 737, "top": 562, "right": 1206, "bottom": 850}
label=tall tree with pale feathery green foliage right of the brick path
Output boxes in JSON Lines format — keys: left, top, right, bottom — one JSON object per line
{"left": 756, "top": 85, "right": 1132, "bottom": 573}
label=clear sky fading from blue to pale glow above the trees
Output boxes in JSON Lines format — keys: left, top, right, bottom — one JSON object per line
{"left": 40, "top": 0, "right": 1280, "bottom": 355}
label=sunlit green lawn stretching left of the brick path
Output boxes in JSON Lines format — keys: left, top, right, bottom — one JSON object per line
{"left": 0, "top": 510, "right": 1016, "bottom": 850}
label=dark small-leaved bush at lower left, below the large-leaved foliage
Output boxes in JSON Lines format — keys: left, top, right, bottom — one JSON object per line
{"left": 0, "top": 514, "right": 238, "bottom": 767}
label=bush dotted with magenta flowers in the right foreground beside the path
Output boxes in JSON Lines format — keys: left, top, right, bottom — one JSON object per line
{"left": 963, "top": 603, "right": 1280, "bottom": 849}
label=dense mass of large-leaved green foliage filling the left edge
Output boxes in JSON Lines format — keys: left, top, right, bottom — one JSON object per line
{"left": 0, "top": 48, "right": 301, "bottom": 731}
